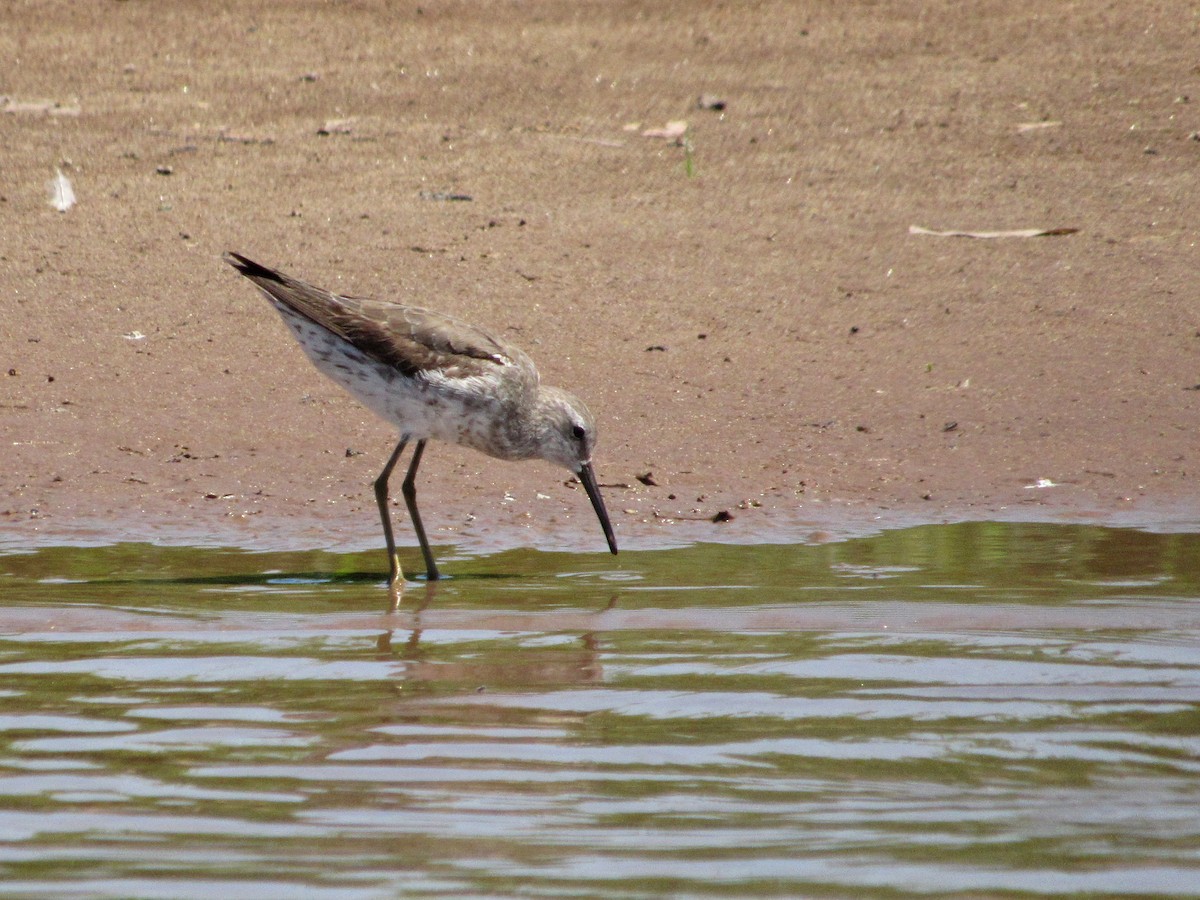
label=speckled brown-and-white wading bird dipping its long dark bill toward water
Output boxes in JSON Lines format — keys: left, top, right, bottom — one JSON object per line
{"left": 224, "top": 253, "right": 617, "bottom": 600}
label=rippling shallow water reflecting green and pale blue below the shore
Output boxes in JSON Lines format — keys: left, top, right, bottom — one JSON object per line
{"left": 0, "top": 523, "right": 1200, "bottom": 900}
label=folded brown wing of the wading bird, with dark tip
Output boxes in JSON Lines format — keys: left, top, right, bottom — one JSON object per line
{"left": 222, "top": 253, "right": 520, "bottom": 378}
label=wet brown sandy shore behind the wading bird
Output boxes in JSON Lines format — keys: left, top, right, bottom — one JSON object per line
{"left": 0, "top": 0, "right": 1200, "bottom": 552}
